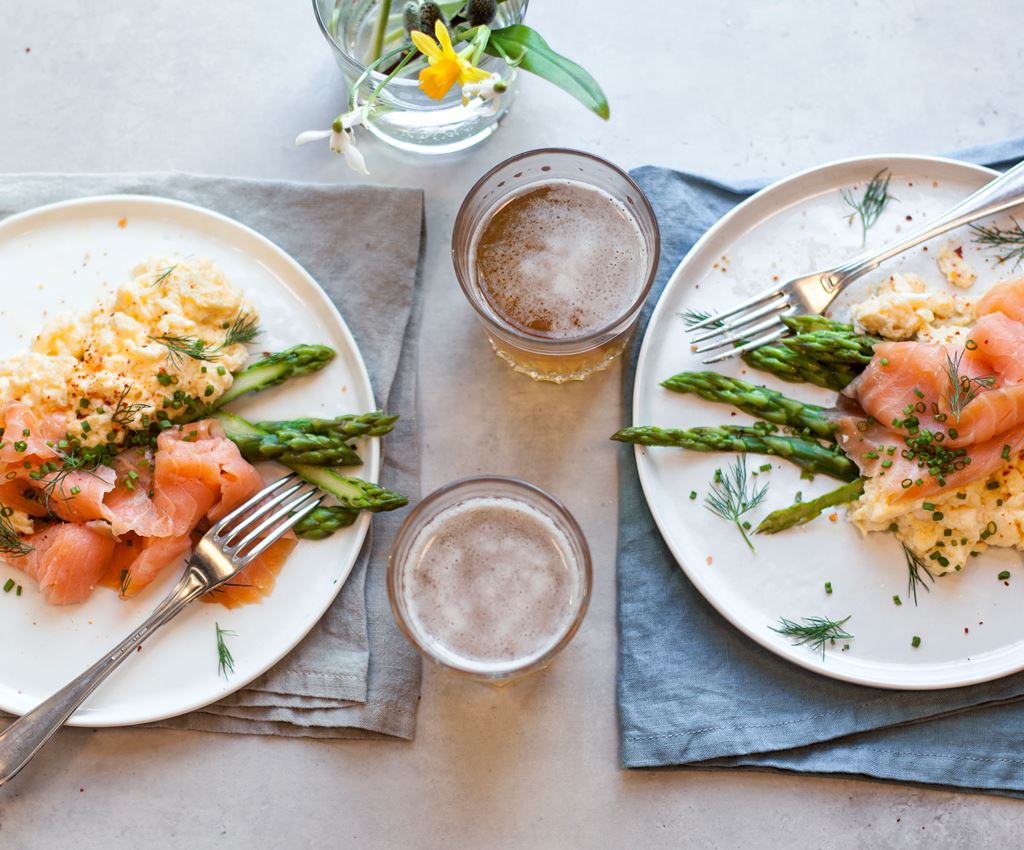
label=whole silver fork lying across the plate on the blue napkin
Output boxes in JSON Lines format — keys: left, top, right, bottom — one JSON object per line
{"left": 687, "top": 156, "right": 1024, "bottom": 364}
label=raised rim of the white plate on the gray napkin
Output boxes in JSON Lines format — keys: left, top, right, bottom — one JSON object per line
{"left": 0, "top": 193, "right": 382, "bottom": 728}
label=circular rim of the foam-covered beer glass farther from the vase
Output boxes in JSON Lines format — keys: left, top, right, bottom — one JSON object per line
{"left": 386, "top": 475, "right": 594, "bottom": 680}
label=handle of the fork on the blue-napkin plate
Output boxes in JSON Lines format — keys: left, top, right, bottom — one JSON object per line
{"left": 836, "top": 163, "right": 1024, "bottom": 293}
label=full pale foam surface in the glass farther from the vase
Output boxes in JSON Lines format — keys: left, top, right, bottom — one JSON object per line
{"left": 400, "top": 497, "right": 582, "bottom": 669}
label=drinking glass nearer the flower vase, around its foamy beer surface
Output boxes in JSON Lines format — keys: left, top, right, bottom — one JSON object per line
{"left": 452, "top": 147, "right": 660, "bottom": 384}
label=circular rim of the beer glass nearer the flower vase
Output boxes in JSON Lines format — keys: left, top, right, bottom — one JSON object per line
{"left": 452, "top": 147, "right": 662, "bottom": 349}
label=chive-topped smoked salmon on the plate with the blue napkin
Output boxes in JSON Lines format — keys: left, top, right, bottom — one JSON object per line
{"left": 835, "top": 279, "right": 1024, "bottom": 502}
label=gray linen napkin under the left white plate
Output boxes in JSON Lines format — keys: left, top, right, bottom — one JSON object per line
{"left": 0, "top": 174, "right": 423, "bottom": 739}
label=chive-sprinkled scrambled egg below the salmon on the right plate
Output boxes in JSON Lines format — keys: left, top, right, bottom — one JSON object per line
{"left": 848, "top": 457, "right": 1024, "bottom": 576}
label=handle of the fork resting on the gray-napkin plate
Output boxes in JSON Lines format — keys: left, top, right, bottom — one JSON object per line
{"left": 0, "top": 567, "right": 209, "bottom": 785}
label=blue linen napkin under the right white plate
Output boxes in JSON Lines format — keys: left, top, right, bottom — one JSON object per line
{"left": 617, "top": 138, "right": 1024, "bottom": 797}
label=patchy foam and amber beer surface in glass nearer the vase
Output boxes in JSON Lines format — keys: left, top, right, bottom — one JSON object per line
{"left": 475, "top": 180, "right": 647, "bottom": 339}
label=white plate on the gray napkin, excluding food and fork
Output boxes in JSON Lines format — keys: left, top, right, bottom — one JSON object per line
{"left": 0, "top": 196, "right": 380, "bottom": 726}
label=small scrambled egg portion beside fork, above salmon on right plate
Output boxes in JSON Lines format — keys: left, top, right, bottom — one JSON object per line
{"left": 851, "top": 273, "right": 977, "bottom": 340}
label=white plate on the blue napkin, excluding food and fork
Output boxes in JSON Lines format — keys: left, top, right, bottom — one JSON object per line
{"left": 633, "top": 156, "right": 1024, "bottom": 688}
